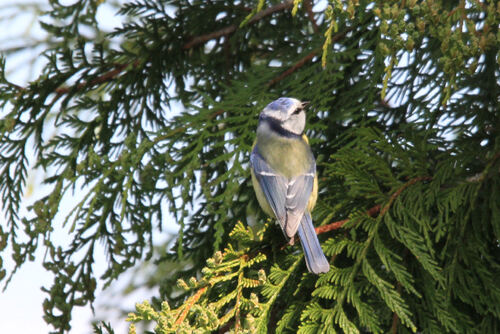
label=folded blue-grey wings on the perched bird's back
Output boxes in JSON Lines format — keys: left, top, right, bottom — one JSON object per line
{"left": 250, "top": 150, "right": 316, "bottom": 239}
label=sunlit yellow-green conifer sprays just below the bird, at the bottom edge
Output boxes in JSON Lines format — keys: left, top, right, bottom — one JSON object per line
{"left": 127, "top": 222, "right": 300, "bottom": 333}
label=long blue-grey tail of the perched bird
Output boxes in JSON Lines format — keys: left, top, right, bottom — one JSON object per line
{"left": 298, "top": 212, "right": 330, "bottom": 274}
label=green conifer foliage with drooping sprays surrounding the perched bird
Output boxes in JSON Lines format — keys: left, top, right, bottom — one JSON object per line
{"left": 0, "top": 0, "right": 500, "bottom": 333}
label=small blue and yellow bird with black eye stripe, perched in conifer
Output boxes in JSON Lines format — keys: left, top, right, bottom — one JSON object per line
{"left": 250, "top": 97, "right": 330, "bottom": 274}
